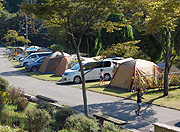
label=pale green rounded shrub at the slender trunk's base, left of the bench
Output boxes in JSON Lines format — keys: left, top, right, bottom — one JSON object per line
{"left": 65, "top": 114, "right": 99, "bottom": 132}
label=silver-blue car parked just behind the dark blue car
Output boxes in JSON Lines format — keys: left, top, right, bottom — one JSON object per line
{"left": 19, "top": 52, "right": 51, "bottom": 66}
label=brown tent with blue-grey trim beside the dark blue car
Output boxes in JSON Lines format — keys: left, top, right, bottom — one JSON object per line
{"left": 39, "top": 51, "right": 70, "bottom": 73}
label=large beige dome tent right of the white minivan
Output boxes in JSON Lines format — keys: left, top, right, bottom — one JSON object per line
{"left": 109, "top": 59, "right": 159, "bottom": 90}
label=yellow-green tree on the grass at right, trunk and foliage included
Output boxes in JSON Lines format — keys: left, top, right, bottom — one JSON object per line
{"left": 118, "top": 0, "right": 180, "bottom": 96}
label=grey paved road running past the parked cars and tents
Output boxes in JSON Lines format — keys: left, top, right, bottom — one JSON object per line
{"left": 0, "top": 46, "right": 180, "bottom": 132}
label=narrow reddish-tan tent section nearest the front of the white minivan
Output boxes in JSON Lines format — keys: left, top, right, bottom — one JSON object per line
{"left": 54, "top": 56, "right": 72, "bottom": 76}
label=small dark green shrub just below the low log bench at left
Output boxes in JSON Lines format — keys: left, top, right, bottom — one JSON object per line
{"left": 36, "top": 102, "right": 54, "bottom": 116}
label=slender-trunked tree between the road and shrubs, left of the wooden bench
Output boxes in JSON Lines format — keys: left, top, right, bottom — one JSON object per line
{"left": 22, "top": 0, "right": 117, "bottom": 116}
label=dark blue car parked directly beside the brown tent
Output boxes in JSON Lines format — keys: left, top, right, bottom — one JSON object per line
{"left": 25, "top": 56, "right": 46, "bottom": 72}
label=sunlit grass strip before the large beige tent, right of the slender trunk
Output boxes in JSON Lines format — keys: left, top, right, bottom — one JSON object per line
{"left": 83, "top": 82, "right": 180, "bottom": 110}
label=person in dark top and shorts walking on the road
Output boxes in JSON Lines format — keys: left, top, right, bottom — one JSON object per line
{"left": 135, "top": 88, "right": 144, "bottom": 116}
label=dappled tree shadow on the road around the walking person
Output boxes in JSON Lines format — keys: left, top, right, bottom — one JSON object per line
{"left": 73, "top": 100, "right": 158, "bottom": 129}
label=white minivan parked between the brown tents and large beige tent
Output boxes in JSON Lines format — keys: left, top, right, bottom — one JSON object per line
{"left": 62, "top": 61, "right": 114, "bottom": 83}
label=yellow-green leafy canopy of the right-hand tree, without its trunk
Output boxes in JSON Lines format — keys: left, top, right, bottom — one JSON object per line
{"left": 119, "top": 0, "right": 180, "bottom": 34}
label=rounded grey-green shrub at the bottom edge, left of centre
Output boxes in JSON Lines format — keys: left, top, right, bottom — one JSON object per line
{"left": 26, "top": 108, "right": 51, "bottom": 132}
